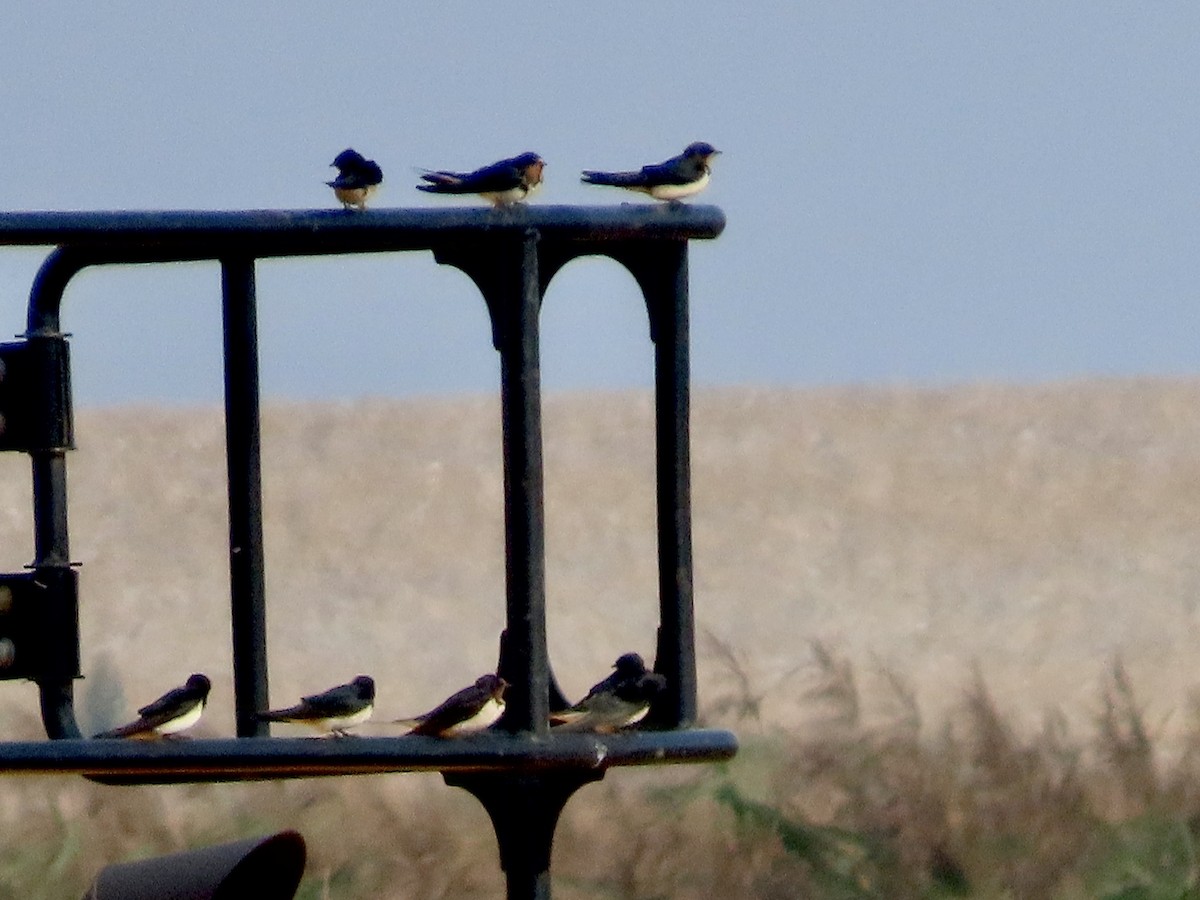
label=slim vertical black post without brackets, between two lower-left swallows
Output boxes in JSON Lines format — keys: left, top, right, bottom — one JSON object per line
{"left": 221, "top": 257, "right": 268, "bottom": 737}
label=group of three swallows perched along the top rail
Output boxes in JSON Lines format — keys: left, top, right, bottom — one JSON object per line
{"left": 325, "top": 140, "right": 720, "bottom": 210}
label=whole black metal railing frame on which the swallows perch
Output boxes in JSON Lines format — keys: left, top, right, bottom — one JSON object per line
{"left": 0, "top": 205, "right": 737, "bottom": 898}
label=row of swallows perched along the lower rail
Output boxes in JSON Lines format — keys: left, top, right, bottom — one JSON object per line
{"left": 96, "top": 653, "right": 666, "bottom": 739}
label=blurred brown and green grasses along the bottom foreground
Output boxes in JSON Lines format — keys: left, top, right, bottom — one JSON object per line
{"left": 0, "top": 647, "right": 1200, "bottom": 900}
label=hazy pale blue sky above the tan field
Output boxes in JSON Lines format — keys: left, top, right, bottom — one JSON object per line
{"left": 0, "top": 0, "right": 1200, "bottom": 406}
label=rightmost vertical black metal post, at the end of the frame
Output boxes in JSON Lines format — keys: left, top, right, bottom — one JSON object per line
{"left": 642, "top": 241, "right": 696, "bottom": 727}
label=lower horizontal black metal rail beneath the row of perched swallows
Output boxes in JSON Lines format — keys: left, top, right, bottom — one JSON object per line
{"left": 0, "top": 730, "right": 737, "bottom": 782}
